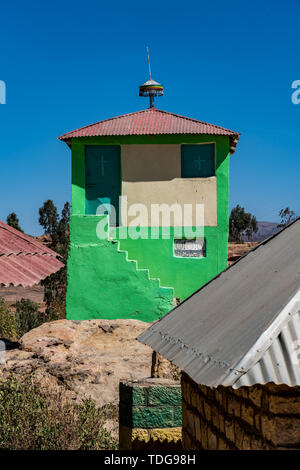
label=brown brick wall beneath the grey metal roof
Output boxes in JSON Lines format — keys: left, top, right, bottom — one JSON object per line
{"left": 182, "top": 373, "right": 300, "bottom": 450}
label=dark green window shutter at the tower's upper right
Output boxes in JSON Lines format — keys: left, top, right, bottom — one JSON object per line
{"left": 181, "top": 144, "right": 215, "bottom": 178}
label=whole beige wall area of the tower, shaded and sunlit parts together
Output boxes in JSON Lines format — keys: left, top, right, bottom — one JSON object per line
{"left": 121, "top": 144, "right": 217, "bottom": 227}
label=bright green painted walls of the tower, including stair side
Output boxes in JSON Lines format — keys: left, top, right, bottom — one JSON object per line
{"left": 67, "top": 135, "right": 229, "bottom": 321}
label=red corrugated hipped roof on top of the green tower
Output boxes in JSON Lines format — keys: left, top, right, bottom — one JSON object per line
{"left": 58, "top": 108, "right": 240, "bottom": 151}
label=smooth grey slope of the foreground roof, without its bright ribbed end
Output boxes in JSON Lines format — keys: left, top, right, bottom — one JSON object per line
{"left": 138, "top": 219, "right": 300, "bottom": 387}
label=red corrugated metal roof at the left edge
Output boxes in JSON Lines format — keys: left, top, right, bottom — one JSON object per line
{"left": 0, "top": 221, "right": 64, "bottom": 287}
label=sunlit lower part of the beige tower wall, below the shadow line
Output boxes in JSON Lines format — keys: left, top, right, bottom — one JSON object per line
{"left": 121, "top": 176, "right": 218, "bottom": 227}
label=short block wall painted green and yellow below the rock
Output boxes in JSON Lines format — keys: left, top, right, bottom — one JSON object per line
{"left": 119, "top": 378, "right": 182, "bottom": 451}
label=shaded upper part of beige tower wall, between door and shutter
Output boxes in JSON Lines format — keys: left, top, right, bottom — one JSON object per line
{"left": 121, "top": 144, "right": 181, "bottom": 182}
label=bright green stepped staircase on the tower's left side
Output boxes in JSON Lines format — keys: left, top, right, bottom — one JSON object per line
{"left": 66, "top": 216, "right": 174, "bottom": 322}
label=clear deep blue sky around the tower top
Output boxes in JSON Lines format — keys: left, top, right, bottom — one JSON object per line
{"left": 0, "top": 0, "right": 300, "bottom": 234}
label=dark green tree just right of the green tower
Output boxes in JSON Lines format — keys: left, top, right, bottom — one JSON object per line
{"left": 229, "top": 205, "right": 258, "bottom": 243}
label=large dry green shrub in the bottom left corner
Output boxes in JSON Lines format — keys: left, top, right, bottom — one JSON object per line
{"left": 0, "top": 378, "right": 117, "bottom": 450}
